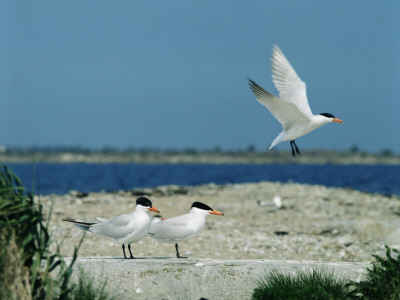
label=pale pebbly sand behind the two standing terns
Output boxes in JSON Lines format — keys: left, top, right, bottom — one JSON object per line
{"left": 40, "top": 182, "right": 400, "bottom": 262}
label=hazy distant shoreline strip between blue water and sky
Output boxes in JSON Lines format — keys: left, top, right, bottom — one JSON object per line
{"left": 0, "top": 150, "right": 400, "bottom": 165}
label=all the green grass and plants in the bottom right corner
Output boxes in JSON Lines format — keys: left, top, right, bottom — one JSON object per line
{"left": 252, "top": 246, "right": 400, "bottom": 300}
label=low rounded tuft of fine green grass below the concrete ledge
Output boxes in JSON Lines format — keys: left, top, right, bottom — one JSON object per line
{"left": 252, "top": 269, "right": 350, "bottom": 300}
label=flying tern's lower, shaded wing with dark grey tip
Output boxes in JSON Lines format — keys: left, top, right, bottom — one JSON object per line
{"left": 249, "top": 79, "right": 308, "bottom": 130}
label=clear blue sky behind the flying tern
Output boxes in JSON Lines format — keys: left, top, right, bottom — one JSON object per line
{"left": 0, "top": 0, "right": 400, "bottom": 153}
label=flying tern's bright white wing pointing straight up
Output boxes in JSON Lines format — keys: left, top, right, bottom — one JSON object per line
{"left": 271, "top": 46, "right": 312, "bottom": 117}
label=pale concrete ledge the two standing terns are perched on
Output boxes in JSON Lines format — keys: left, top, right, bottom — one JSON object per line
{"left": 66, "top": 257, "right": 370, "bottom": 299}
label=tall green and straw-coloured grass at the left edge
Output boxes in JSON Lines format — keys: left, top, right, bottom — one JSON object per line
{"left": 0, "top": 165, "right": 114, "bottom": 300}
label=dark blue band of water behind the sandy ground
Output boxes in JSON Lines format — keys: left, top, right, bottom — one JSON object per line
{"left": 9, "top": 163, "right": 400, "bottom": 195}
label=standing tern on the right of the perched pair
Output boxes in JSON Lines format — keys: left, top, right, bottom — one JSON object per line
{"left": 149, "top": 202, "right": 224, "bottom": 258}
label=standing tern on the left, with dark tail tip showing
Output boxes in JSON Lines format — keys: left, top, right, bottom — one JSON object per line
{"left": 63, "top": 197, "right": 159, "bottom": 258}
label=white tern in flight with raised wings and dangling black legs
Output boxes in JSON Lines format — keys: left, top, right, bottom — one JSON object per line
{"left": 249, "top": 46, "right": 343, "bottom": 156}
